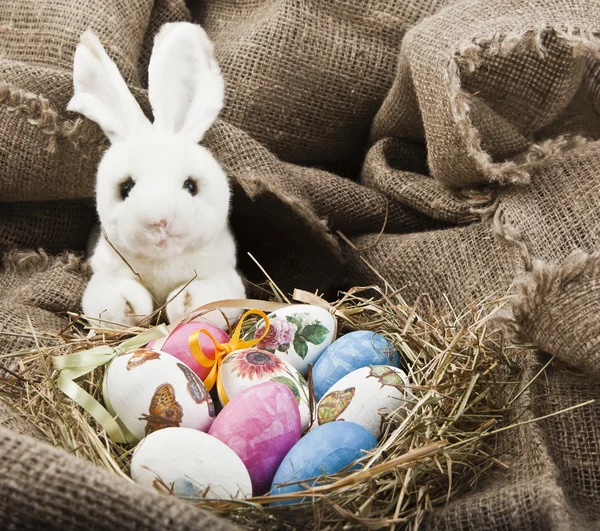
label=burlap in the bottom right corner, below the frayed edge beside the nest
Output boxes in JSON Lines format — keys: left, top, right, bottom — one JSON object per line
{"left": 423, "top": 356, "right": 600, "bottom": 531}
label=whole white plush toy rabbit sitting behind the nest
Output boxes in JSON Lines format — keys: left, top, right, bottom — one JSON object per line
{"left": 67, "top": 23, "right": 245, "bottom": 325}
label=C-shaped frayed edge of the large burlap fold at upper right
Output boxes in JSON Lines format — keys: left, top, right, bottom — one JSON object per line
{"left": 445, "top": 25, "right": 600, "bottom": 184}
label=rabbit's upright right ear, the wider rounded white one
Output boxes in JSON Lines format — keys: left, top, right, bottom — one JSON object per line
{"left": 148, "top": 22, "right": 224, "bottom": 142}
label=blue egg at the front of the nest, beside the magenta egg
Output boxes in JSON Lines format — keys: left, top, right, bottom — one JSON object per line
{"left": 271, "top": 422, "right": 377, "bottom": 505}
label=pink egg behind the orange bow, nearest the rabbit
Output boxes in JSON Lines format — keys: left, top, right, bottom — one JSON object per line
{"left": 147, "top": 321, "right": 229, "bottom": 381}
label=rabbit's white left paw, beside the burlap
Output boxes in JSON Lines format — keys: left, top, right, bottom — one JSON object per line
{"left": 82, "top": 275, "right": 154, "bottom": 328}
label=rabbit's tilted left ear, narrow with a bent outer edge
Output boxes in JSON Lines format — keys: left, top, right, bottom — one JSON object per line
{"left": 67, "top": 31, "right": 150, "bottom": 142}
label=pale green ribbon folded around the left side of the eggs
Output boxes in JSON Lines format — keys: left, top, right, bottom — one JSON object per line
{"left": 52, "top": 325, "right": 169, "bottom": 443}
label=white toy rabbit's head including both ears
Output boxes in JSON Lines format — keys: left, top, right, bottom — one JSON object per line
{"left": 67, "top": 23, "right": 229, "bottom": 258}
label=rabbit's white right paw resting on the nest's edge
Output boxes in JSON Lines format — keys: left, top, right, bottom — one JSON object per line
{"left": 167, "top": 273, "right": 245, "bottom": 330}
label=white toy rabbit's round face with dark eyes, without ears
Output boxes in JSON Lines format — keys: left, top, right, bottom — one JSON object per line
{"left": 97, "top": 132, "right": 229, "bottom": 258}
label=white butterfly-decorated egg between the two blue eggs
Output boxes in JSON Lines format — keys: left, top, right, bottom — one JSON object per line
{"left": 312, "top": 365, "right": 412, "bottom": 437}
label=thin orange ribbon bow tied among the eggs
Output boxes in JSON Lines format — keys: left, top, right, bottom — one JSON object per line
{"left": 188, "top": 310, "right": 271, "bottom": 405}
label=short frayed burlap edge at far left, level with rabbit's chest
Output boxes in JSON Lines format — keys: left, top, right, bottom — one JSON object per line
{"left": 2, "top": 249, "right": 91, "bottom": 276}
